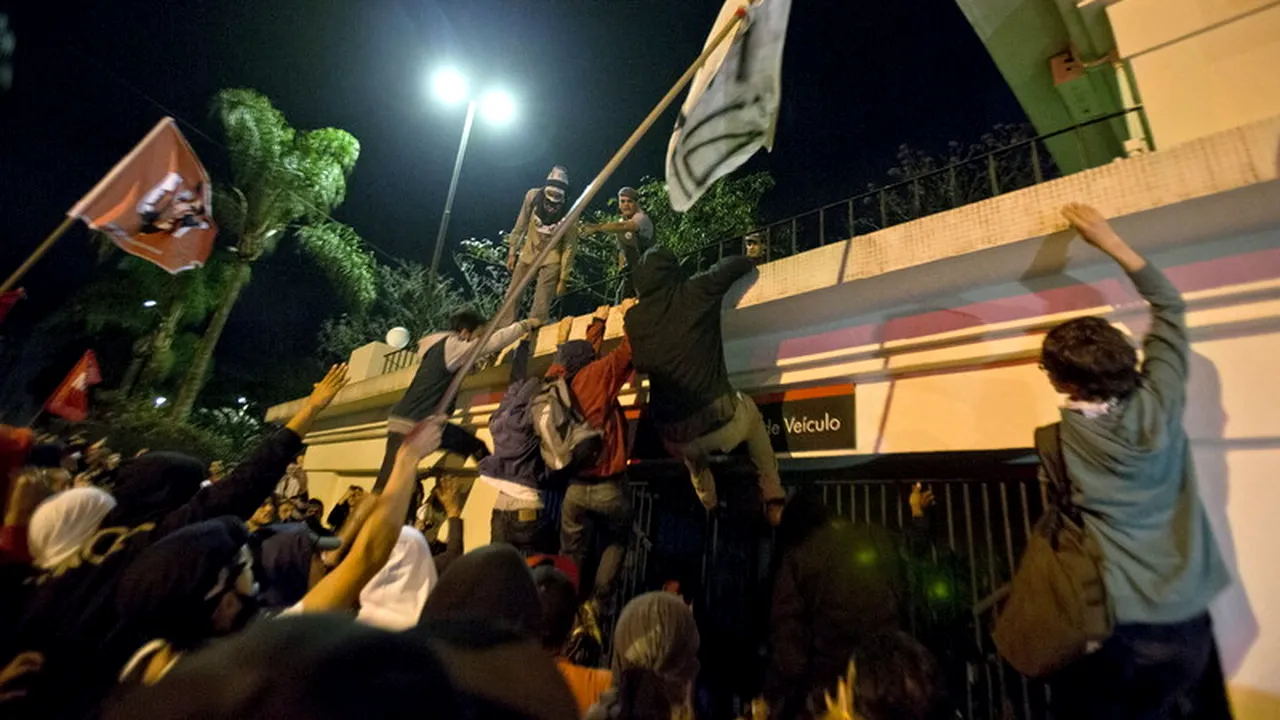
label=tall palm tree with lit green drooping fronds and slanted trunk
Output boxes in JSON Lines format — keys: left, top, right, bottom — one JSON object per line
{"left": 173, "top": 88, "right": 374, "bottom": 420}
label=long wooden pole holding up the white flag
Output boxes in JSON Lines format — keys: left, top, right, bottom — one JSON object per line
{"left": 435, "top": 5, "right": 746, "bottom": 415}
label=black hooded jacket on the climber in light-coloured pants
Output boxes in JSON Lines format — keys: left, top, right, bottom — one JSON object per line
{"left": 626, "top": 247, "right": 754, "bottom": 437}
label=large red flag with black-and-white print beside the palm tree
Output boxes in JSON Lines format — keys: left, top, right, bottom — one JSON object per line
{"left": 67, "top": 118, "right": 218, "bottom": 273}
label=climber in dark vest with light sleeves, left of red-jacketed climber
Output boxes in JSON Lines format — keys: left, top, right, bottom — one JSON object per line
{"left": 374, "top": 309, "right": 541, "bottom": 492}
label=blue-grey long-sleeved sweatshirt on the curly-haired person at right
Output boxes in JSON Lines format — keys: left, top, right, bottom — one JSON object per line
{"left": 1060, "top": 263, "right": 1230, "bottom": 623}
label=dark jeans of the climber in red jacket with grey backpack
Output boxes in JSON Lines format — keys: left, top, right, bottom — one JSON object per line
{"left": 561, "top": 475, "right": 631, "bottom": 612}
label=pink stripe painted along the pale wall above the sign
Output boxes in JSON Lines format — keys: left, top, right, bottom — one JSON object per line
{"left": 778, "top": 249, "right": 1280, "bottom": 360}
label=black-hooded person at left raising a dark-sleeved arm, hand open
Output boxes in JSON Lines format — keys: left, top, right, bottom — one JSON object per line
{"left": 0, "top": 365, "right": 347, "bottom": 716}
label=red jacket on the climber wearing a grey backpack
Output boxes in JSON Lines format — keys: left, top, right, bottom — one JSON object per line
{"left": 547, "top": 318, "right": 632, "bottom": 478}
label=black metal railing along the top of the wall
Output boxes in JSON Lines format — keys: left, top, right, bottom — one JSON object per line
{"left": 561, "top": 105, "right": 1151, "bottom": 315}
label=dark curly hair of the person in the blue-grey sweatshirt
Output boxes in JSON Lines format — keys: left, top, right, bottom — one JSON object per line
{"left": 1041, "top": 318, "right": 1140, "bottom": 401}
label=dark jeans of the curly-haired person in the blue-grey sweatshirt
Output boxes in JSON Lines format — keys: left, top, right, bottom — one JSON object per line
{"left": 1050, "top": 612, "right": 1231, "bottom": 720}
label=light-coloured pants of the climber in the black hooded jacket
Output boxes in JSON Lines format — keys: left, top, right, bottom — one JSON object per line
{"left": 663, "top": 392, "right": 786, "bottom": 510}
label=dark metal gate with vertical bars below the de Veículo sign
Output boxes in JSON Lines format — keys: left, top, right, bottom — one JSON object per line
{"left": 604, "top": 478, "right": 1047, "bottom": 720}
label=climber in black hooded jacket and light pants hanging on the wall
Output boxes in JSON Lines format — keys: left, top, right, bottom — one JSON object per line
{"left": 626, "top": 247, "right": 785, "bottom": 525}
